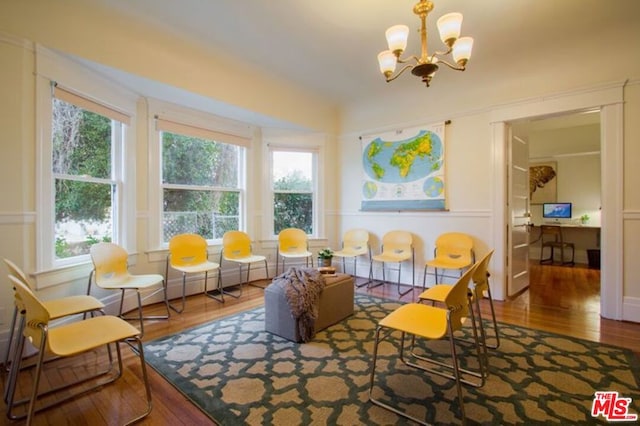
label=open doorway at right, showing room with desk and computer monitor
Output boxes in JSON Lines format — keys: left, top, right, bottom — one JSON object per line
{"left": 509, "top": 110, "right": 601, "bottom": 315}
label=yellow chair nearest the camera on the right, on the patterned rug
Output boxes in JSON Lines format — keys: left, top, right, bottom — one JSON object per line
{"left": 369, "top": 267, "right": 479, "bottom": 424}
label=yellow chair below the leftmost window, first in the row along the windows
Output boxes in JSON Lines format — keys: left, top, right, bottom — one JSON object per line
{"left": 87, "top": 243, "right": 170, "bottom": 337}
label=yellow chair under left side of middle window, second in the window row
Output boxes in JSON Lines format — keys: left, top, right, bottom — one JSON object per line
{"left": 164, "top": 234, "right": 224, "bottom": 313}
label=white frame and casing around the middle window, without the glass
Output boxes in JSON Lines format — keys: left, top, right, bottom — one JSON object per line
{"left": 147, "top": 99, "right": 253, "bottom": 250}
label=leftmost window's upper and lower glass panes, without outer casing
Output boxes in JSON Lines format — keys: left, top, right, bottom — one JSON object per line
{"left": 51, "top": 95, "right": 123, "bottom": 260}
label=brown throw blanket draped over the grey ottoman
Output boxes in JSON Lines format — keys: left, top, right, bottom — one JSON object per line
{"left": 273, "top": 268, "right": 325, "bottom": 342}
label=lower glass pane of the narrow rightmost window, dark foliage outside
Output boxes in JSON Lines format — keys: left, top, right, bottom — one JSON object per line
{"left": 273, "top": 193, "right": 313, "bottom": 235}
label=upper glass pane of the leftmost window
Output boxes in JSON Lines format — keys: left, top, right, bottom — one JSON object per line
{"left": 52, "top": 99, "right": 111, "bottom": 179}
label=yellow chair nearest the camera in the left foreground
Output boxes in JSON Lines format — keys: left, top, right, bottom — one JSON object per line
{"left": 7, "top": 276, "right": 151, "bottom": 425}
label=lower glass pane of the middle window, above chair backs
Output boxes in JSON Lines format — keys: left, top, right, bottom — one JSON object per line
{"left": 162, "top": 189, "right": 240, "bottom": 242}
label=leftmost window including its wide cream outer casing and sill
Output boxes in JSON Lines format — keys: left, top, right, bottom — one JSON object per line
{"left": 34, "top": 46, "right": 138, "bottom": 280}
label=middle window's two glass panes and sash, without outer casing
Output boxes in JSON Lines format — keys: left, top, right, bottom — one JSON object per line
{"left": 157, "top": 120, "right": 245, "bottom": 243}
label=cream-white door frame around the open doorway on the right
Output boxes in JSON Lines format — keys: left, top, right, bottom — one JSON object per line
{"left": 490, "top": 82, "right": 624, "bottom": 320}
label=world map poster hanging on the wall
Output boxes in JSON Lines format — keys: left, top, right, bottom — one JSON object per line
{"left": 361, "top": 123, "right": 446, "bottom": 211}
